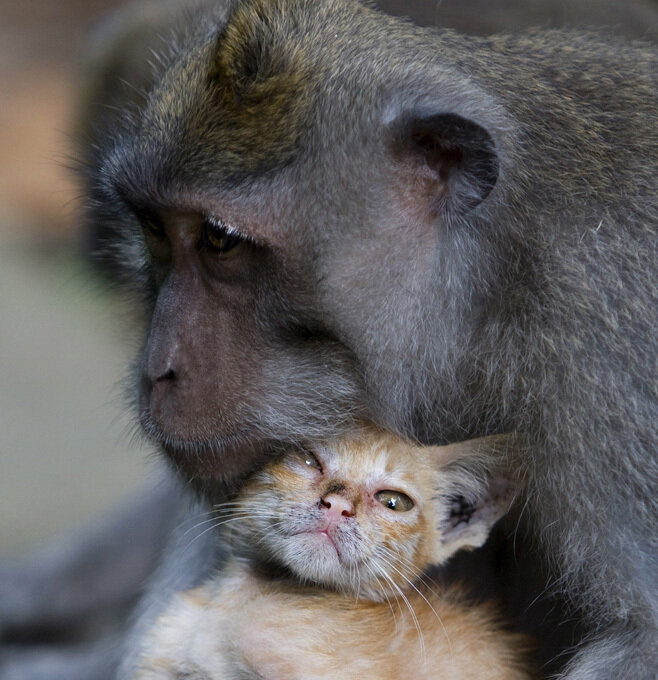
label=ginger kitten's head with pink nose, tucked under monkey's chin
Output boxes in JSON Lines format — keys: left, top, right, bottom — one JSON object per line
{"left": 227, "top": 430, "right": 518, "bottom": 599}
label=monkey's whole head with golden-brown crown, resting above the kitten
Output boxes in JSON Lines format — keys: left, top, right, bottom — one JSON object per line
{"left": 92, "top": 0, "right": 509, "bottom": 488}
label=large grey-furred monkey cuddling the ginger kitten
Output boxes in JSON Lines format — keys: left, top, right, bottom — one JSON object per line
{"left": 6, "top": 0, "right": 658, "bottom": 680}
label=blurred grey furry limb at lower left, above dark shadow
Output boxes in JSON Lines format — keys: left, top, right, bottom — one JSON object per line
{"left": 0, "top": 477, "right": 185, "bottom": 642}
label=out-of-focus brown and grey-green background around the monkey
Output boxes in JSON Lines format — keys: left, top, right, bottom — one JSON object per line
{"left": 0, "top": 0, "right": 658, "bottom": 558}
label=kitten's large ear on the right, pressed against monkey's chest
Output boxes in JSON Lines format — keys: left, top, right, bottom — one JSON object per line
{"left": 434, "top": 435, "right": 524, "bottom": 564}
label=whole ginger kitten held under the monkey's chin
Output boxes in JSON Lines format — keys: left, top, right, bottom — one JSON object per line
{"left": 137, "top": 430, "right": 533, "bottom": 680}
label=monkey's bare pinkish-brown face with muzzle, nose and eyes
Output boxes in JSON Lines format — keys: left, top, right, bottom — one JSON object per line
{"left": 128, "top": 202, "right": 363, "bottom": 479}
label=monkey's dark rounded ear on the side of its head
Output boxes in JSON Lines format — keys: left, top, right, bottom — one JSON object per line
{"left": 389, "top": 111, "right": 500, "bottom": 214}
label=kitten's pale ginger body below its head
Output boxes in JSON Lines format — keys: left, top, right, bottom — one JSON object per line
{"left": 138, "top": 562, "right": 531, "bottom": 680}
